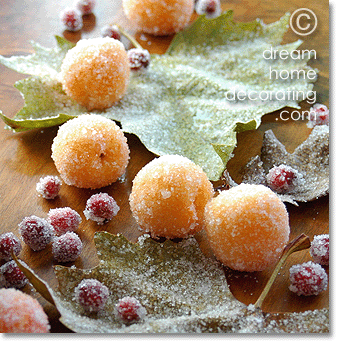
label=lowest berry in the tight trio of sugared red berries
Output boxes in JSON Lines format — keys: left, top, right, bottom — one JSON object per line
{"left": 52, "top": 232, "right": 83, "bottom": 262}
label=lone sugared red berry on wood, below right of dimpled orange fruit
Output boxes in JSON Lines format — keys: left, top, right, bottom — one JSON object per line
{"left": 83, "top": 193, "right": 119, "bottom": 225}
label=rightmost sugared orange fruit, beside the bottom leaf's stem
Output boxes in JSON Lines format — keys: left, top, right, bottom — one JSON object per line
{"left": 205, "top": 184, "right": 290, "bottom": 272}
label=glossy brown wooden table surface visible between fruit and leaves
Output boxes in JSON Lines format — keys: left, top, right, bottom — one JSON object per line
{"left": 0, "top": 0, "right": 329, "bottom": 332}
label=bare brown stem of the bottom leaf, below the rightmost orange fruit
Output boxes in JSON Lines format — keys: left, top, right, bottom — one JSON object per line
{"left": 254, "top": 233, "right": 310, "bottom": 308}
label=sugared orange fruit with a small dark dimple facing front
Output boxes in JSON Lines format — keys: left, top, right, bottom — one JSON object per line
{"left": 52, "top": 114, "right": 129, "bottom": 189}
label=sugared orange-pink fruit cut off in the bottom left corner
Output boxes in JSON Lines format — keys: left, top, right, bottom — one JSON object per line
{"left": 0, "top": 288, "right": 50, "bottom": 333}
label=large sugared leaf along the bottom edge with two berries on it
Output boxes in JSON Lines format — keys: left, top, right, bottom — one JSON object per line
{"left": 13, "top": 232, "right": 329, "bottom": 333}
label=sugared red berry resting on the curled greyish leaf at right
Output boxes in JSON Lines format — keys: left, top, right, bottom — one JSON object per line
{"left": 267, "top": 164, "right": 303, "bottom": 193}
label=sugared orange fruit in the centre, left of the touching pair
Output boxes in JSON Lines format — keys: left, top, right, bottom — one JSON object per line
{"left": 130, "top": 155, "right": 213, "bottom": 238}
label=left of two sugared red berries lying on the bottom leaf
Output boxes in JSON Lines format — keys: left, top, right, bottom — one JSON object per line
{"left": 75, "top": 279, "right": 109, "bottom": 312}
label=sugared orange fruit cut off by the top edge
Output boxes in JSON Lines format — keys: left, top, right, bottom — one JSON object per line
{"left": 123, "top": 0, "right": 194, "bottom": 36}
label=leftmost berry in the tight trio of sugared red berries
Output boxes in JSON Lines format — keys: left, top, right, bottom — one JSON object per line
{"left": 19, "top": 215, "right": 54, "bottom": 251}
